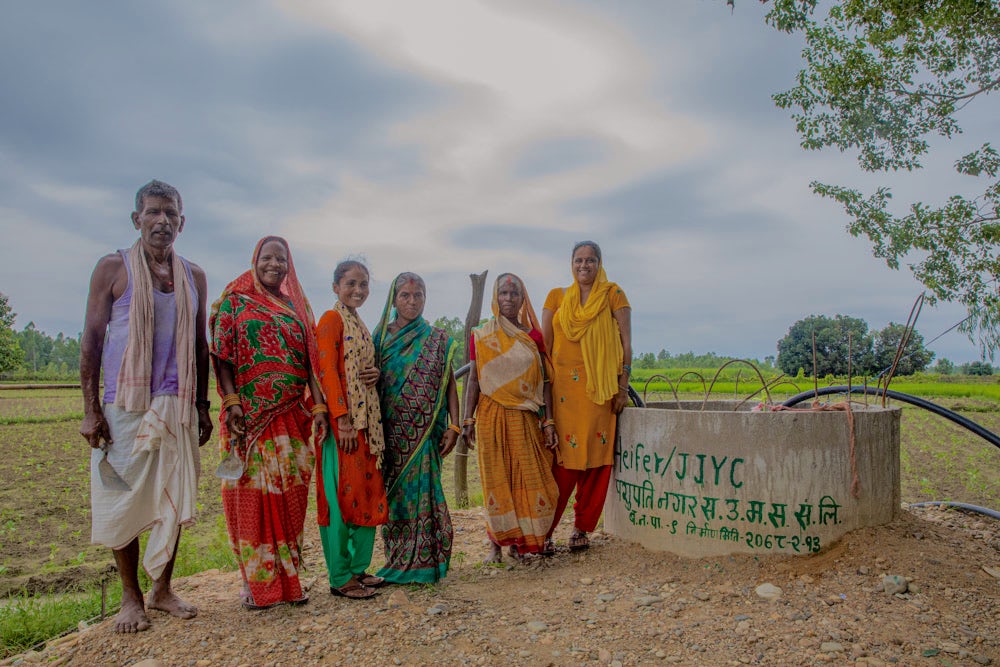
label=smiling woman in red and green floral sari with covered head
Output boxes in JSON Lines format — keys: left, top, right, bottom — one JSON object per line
{"left": 209, "top": 236, "right": 329, "bottom": 609}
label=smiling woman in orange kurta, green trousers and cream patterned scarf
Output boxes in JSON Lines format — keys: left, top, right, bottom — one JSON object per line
{"left": 316, "top": 259, "right": 388, "bottom": 600}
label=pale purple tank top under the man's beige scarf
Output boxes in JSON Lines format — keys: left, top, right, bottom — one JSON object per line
{"left": 101, "top": 250, "right": 199, "bottom": 403}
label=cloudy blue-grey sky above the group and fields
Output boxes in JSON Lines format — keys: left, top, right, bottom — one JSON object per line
{"left": 0, "top": 0, "right": 995, "bottom": 362}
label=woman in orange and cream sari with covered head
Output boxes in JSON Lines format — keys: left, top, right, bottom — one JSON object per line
{"left": 463, "top": 273, "right": 559, "bottom": 563}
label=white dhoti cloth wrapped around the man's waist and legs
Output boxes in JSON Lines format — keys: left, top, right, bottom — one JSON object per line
{"left": 90, "top": 396, "right": 201, "bottom": 579}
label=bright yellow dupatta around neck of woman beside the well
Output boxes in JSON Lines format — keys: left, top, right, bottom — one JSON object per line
{"left": 555, "top": 265, "right": 625, "bottom": 405}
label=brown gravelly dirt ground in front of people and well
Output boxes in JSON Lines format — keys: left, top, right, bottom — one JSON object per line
{"left": 6, "top": 509, "right": 1000, "bottom": 667}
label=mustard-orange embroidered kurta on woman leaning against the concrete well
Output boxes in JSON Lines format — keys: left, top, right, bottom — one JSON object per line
{"left": 544, "top": 283, "right": 631, "bottom": 470}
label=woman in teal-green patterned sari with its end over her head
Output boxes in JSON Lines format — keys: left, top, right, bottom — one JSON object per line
{"left": 373, "top": 273, "right": 461, "bottom": 584}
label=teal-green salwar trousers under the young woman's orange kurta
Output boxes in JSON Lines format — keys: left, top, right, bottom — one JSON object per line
{"left": 319, "top": 434, "right": 375, "bottom": 588}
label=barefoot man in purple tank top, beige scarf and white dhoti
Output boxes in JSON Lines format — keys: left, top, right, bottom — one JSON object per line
{"left": 80, "top": 180, "right": 212, "bottom": 632}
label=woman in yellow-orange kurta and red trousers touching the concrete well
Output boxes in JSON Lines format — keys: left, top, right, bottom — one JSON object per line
{"left": 542, "top": 241, "right": 632, "bottom": 550}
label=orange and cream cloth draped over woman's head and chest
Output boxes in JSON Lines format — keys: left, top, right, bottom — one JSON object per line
{"left": 472, "top": 273, "right": 545, "bottom": 412}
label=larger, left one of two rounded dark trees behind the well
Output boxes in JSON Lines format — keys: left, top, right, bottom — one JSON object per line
{"left": 778, "top": 315, "right": 872, "bottom": 377}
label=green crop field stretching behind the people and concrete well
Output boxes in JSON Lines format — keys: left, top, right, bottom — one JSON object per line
{"left": 0, "top": 380, "right": 1000, "bottom": 657}
